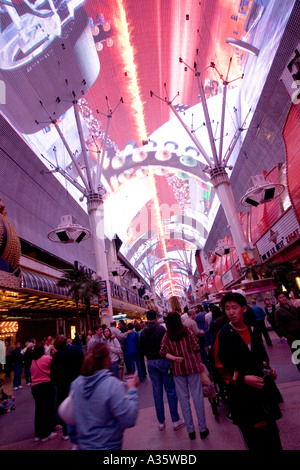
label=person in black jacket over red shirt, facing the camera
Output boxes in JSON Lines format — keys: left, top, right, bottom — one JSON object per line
{"left": 214, "top": 292, "right": 282, "bottom": 452}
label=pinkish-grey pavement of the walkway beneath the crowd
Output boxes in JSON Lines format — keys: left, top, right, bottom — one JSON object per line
{"left": 0, "top": 332, "right": 300, "bottom": 452}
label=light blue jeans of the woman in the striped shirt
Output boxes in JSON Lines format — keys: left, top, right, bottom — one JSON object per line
{"left": 174, "top": 374, "right": 206, "bottom": 433}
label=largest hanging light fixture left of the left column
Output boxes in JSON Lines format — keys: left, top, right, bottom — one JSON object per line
{"left": 48, "top": 215, "right": 91, "bottom": 244}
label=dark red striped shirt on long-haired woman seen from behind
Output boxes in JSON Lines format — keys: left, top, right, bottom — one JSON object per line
{"left": 160, "top": 328, "right": 203, "bottom": 375}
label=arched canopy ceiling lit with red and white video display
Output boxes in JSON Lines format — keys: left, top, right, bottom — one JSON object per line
{"left": 0, "top": 0, "right": 294, "bottom": 297}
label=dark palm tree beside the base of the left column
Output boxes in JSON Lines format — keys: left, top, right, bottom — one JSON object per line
{"left": 57, "top": 268, "right": 101, "bottom": 331}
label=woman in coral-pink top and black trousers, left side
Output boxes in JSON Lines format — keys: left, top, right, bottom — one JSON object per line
{"left": 30, "top": 342, "right": 56, "bottom": 442}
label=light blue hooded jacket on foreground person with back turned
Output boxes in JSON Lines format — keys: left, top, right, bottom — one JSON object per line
{"left": 71, "top": 369, "right": 139, "bottom": 450}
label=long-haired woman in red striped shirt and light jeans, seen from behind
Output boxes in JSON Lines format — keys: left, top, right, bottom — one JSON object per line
{"left": 160, "top": 312, "right": 209, "bottom": 440}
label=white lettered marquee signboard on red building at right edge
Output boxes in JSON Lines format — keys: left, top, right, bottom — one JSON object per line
{"left": 256, "top": 207, "right": 300, "bottom": 261}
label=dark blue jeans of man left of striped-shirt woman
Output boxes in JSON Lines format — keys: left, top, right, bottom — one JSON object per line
{"left": 147, "top": 359, "right": 180, "bottom": 423}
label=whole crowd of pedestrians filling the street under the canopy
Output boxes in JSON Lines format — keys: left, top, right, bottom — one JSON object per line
{"left": 0, "top": 290, "right": 300, "bottom": 451}
